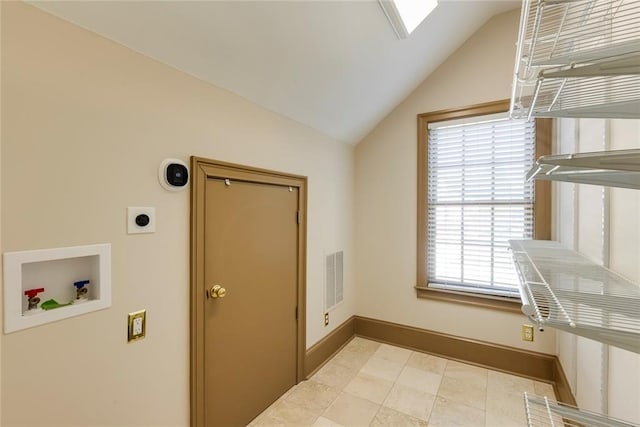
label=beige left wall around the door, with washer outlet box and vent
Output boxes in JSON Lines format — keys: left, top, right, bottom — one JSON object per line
{"left": 0, "top": 2, "right": 355, "bottom": 426}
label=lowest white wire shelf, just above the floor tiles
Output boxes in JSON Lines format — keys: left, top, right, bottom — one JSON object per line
{"left": 524, "top": 392, "right": 635, "bottom": 427}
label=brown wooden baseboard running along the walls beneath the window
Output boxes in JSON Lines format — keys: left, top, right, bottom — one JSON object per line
{"left": 304, "top": 316, "right": 576, "bottom": 406}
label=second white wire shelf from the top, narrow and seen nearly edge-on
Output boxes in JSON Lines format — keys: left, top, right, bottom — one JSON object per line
{"left": 527, "top": 150, "right": 640, "bottom": 189}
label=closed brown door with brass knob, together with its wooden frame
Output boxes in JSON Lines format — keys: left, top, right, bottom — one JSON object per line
{"left": 192, "top": 158, "right": 304, "bottom": 426}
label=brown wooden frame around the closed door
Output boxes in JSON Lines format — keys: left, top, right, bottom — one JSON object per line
{"left": 189, "top": 156, "right": 307, "bottom": 427}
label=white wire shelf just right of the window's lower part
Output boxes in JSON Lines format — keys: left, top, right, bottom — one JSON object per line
{"left": 509, "top": 240, "right": 640, "bottom": 354}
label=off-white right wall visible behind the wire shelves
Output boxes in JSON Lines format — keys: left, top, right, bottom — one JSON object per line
{"left": 554, "top": 119, "right": 640, "bottom": 423}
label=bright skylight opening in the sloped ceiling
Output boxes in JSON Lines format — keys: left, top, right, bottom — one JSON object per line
{"left": 378, "top": 0, "right": 438, "bottom": 39}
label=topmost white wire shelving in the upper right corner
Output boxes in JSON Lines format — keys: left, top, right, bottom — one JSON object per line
{"left": 511, "top": 0, "right": 640, "bottom": 119}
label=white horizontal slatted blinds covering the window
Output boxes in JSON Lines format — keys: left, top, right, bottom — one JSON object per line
{"left": 427, "top": 116, "right": 535, "bottom": 297}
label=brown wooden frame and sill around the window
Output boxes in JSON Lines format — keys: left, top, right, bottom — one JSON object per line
{"left": 415, "top": 99, "right": 552, "bottom": 312}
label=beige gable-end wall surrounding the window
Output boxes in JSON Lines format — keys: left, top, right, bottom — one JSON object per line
{"left": 356, "top": 11, "right": 555, "bottom": 353}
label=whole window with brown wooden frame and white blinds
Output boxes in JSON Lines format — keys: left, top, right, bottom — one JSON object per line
{"left": 417, "top": 101, "right": 550, "bottom": 310}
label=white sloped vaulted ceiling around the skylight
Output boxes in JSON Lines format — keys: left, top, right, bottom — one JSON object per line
{"left": 29, "top": 0, "right": 520, "bottom": 144}
